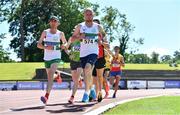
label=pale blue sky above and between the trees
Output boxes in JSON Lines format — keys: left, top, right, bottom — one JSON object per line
{"left": 0, "top": 0, "right": 180, "bottom": 58}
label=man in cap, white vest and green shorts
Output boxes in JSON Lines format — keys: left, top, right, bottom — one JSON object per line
{"left": 37, "top": 16, "right": 67, "bottom": 104}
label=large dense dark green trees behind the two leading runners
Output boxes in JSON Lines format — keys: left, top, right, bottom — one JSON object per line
{"left": 2, "top": 0, "right": 99, "bottom": 61}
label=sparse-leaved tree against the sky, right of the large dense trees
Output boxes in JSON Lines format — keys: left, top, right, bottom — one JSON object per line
{"left": 101, "top": 6, "right": 144, "bottom": 56}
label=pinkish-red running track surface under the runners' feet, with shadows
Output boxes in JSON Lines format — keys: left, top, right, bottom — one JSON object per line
{"left": 0, "top": 89, "right": 180, "bottom": 115}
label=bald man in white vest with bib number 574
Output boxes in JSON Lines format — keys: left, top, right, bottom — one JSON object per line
{"left": 72, "top": 8, "right": 106, "bottom": 102}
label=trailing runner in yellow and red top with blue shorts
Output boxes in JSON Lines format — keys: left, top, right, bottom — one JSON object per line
{"left": 110, "top": 46, "right": 125, "bottom": 98}
